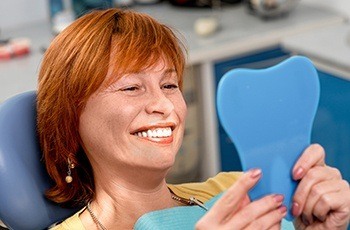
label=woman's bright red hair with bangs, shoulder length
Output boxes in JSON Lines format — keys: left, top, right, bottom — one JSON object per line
{"left": 37, "top": 9, "right": 185, "bottom": 206}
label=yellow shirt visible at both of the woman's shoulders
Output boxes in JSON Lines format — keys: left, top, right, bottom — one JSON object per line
{"left": 50, "top": 172, "right": 242, "bottom": 230}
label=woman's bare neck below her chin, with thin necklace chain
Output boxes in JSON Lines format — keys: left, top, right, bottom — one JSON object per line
{"left": 80, "top": 167, "right": 176, "bottom": 229}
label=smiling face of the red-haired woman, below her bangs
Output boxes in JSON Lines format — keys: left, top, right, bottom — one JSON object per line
{"left": 79, "top": 61, "right": 187, "bottom": 173}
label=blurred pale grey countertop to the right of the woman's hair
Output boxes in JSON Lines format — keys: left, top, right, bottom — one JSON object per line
{"left": 135, "top": 2, "right": 345, "bottom": 64}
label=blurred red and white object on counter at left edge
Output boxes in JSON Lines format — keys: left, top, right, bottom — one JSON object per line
{"left": 0, "top": 38, "right": 30, "bottom": 61}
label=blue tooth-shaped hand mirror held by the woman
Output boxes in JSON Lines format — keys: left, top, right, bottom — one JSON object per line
{"left": 217, "top": 56, "right": 320, "bottom": 220}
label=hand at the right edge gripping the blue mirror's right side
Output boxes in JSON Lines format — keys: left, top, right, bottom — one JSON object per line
{"left": 292, "top": 144, "right": 350, "bottom": 230}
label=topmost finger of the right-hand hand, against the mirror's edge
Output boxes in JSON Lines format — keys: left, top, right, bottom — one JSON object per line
{"left": 292, "top": 144, "right": 325, "bottom": 180}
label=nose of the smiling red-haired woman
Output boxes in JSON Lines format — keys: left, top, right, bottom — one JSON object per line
{"left": 146, "top": 89, "right": 175, "bottom": 117}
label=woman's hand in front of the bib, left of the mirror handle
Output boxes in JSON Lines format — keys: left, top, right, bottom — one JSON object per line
{"left": 196, "top": 169, "right": 287, "bottom": 230}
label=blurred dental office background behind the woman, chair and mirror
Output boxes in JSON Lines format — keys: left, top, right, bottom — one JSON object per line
{"left": 0, "top": 0, "right": 350, "bottom": 185}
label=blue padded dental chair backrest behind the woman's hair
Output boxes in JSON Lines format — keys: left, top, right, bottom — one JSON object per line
{"left": 0, "top": 91, "right": 76, "bottom": 230}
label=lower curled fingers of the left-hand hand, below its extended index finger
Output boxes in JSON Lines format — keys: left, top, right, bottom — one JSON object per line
{"left": 227, "top": 195, "right": 287, "bottom": 229}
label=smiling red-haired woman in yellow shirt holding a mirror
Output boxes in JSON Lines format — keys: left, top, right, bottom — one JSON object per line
{"left": 37, "top": 9, "right": 350, "bottom": 229}
